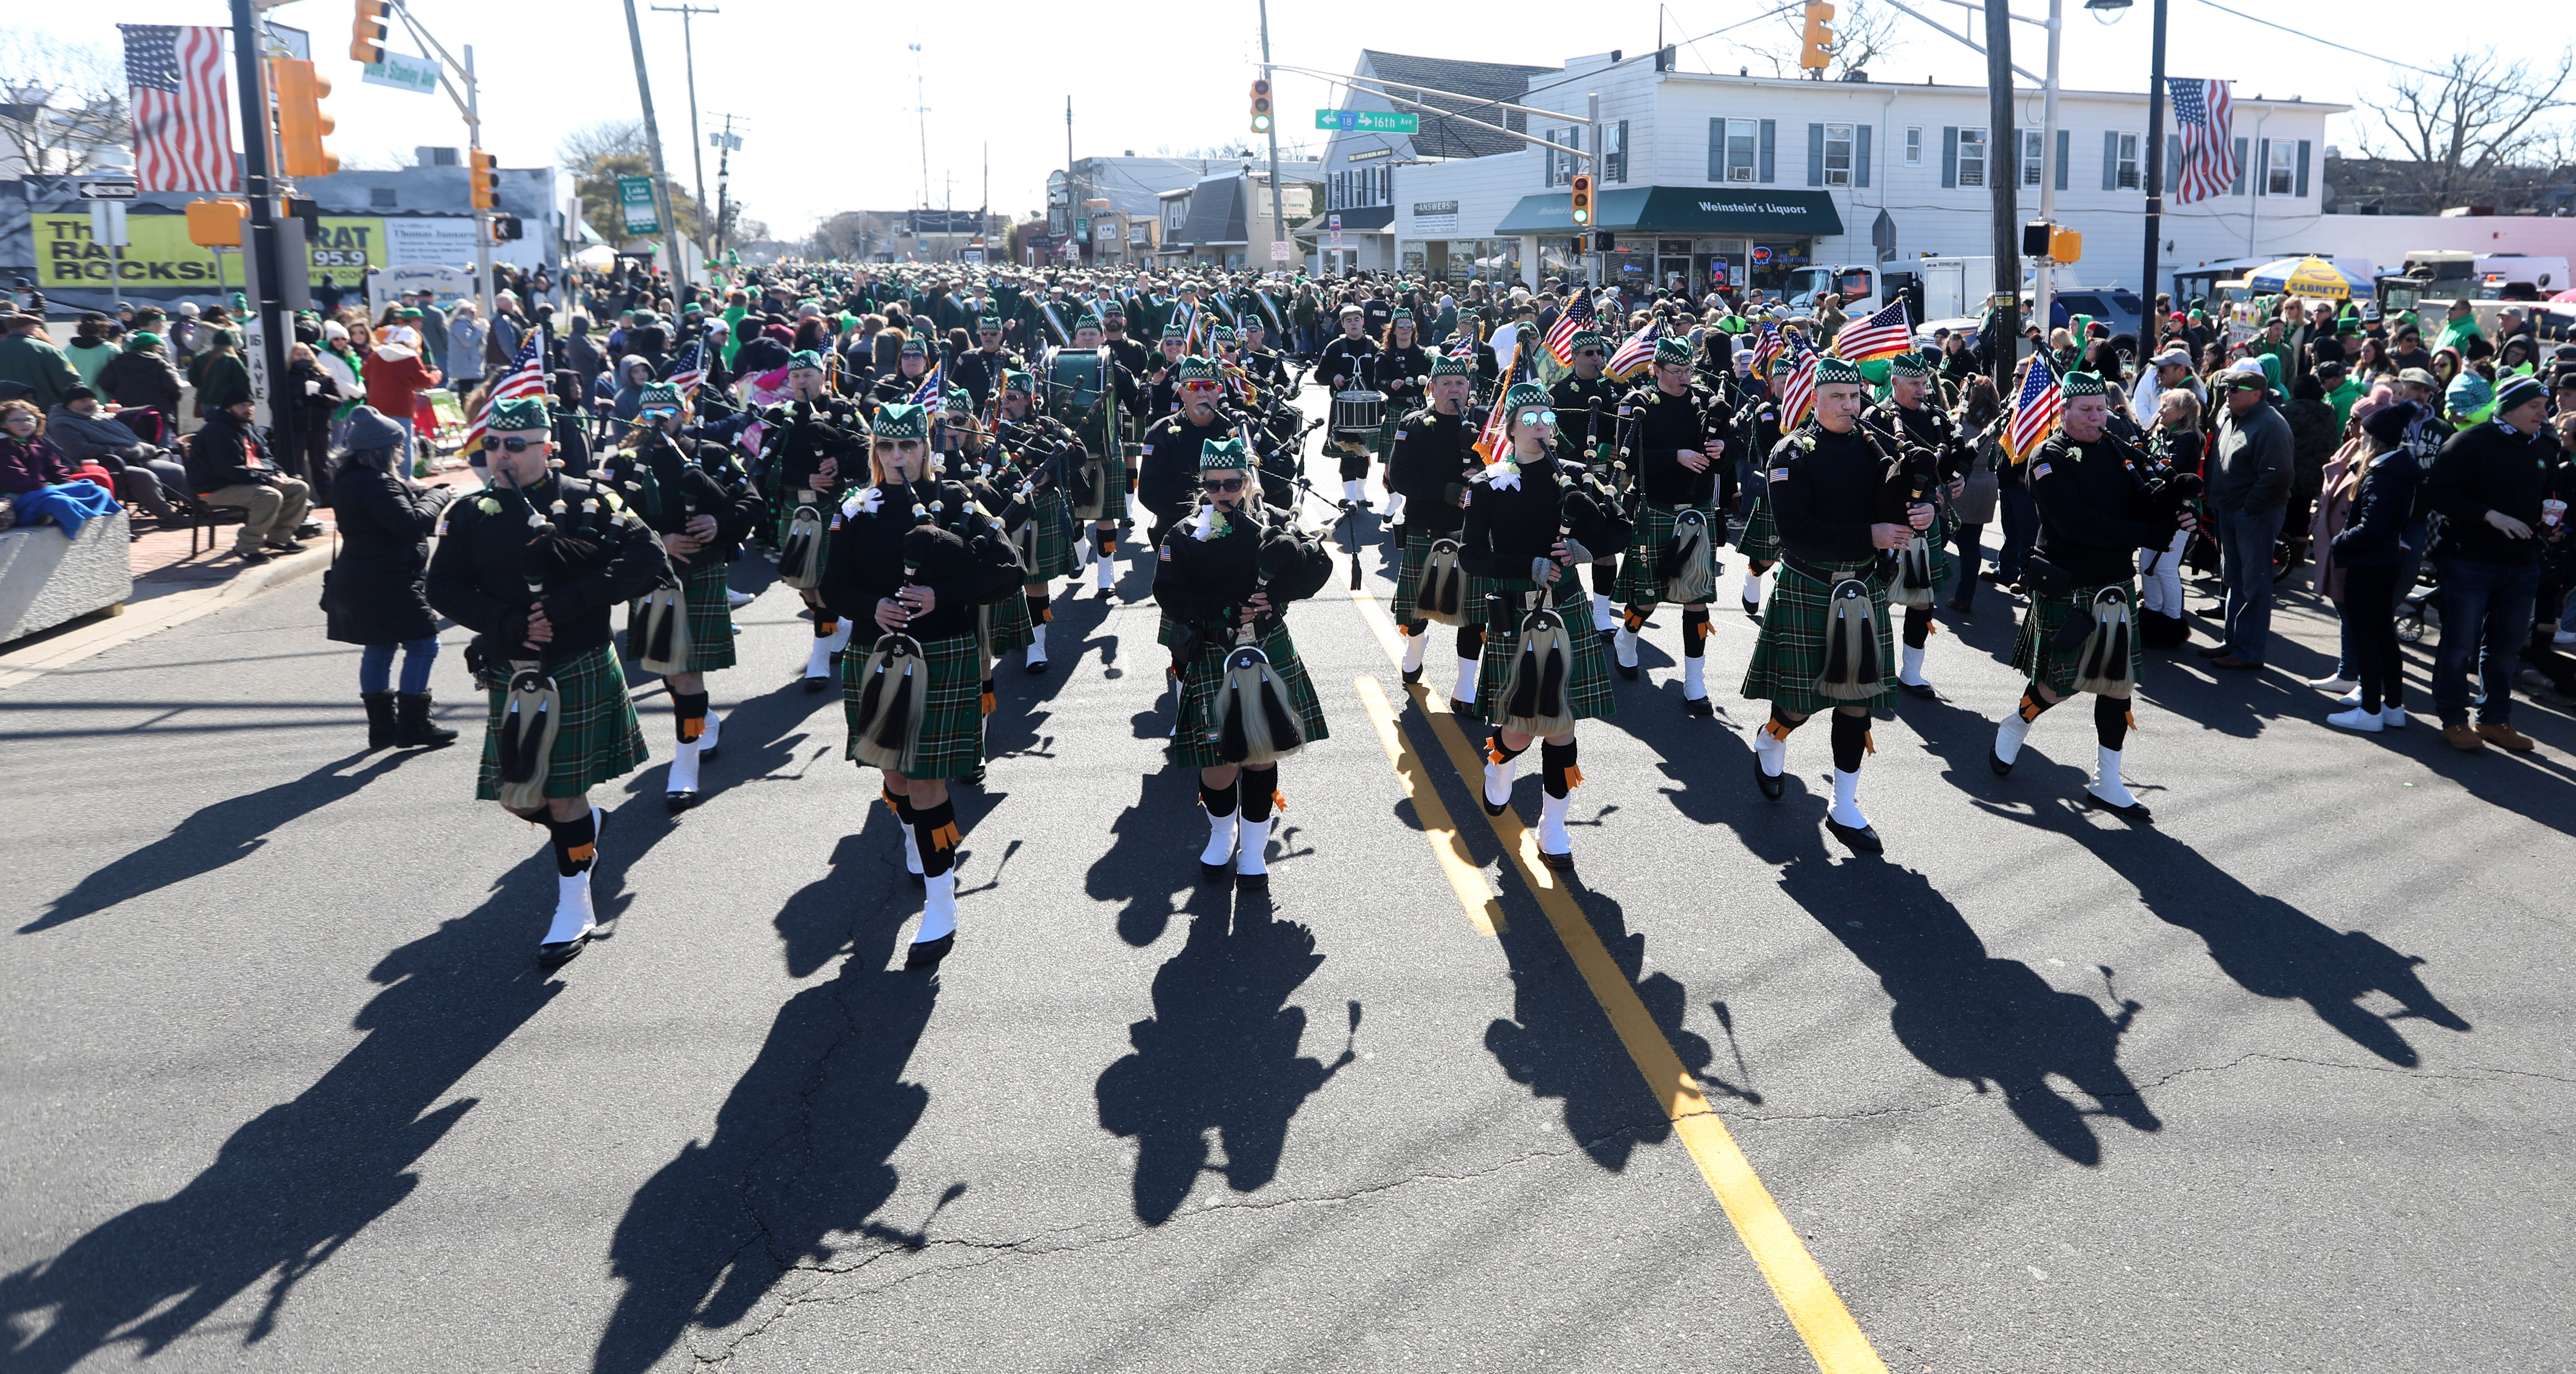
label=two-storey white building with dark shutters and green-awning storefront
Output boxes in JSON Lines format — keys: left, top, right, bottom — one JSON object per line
{"left": 1324, "top": 54, "right": 2344, "bottom": 303}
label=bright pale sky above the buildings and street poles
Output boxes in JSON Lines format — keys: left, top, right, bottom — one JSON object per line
{"left": 31, "top": 0, "right": 2576, "bottom": 237}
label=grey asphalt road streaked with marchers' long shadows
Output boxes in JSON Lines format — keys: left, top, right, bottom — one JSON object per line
{"left": 0, "top": 399, "right": 2576, "bottom": 1374}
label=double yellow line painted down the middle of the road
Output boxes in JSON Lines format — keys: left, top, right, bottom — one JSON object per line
{"left": 1350, "top": 570, "right": 1888, "bottom": 1374}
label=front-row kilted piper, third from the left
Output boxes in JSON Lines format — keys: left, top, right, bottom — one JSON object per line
{"left": 1154, "top": 438, "right": 1332, "bottom": 889}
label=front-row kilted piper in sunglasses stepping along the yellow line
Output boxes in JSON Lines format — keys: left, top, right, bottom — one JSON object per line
{"left": 1458, "top": 382, "right": 1628, "bottom": 871}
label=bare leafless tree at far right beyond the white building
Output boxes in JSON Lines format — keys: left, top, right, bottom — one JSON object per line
{"left": 2360, "top": 49, "right": 2576, "bottom": 206}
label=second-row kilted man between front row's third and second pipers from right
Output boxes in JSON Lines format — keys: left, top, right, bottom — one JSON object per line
{"left": 1610, "top": 335, "right": 1736, "bottom": 717}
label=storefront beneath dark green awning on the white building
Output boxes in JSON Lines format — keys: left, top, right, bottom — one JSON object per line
{"left": 1494, "top": 186, "right": 1842, "bottom": 294}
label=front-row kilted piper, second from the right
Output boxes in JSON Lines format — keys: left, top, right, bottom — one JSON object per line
{"left": 1744, "top": 358, "right": 1932, "bottom": 853}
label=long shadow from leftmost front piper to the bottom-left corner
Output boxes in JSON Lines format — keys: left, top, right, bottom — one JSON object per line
{"left": 0, "top": 856, "right": 561, "bottom": 1371}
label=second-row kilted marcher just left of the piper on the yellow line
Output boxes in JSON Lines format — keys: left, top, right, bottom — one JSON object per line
{"left": 1386, "top": 353, "right": 1484, "bottom": 717}
